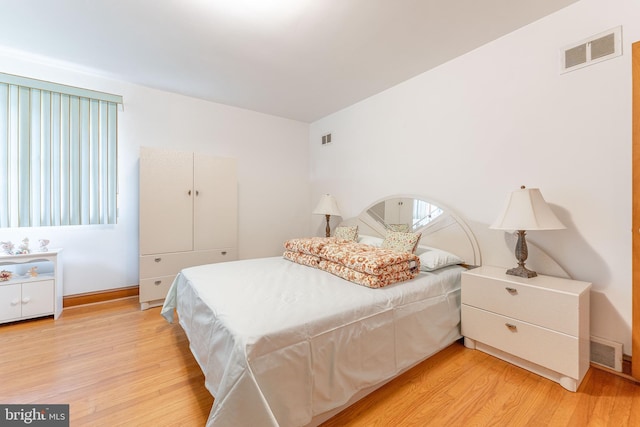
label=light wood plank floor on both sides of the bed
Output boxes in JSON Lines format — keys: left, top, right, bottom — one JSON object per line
{"left": 0, "top": 299, "right": 640, "bottom": 427}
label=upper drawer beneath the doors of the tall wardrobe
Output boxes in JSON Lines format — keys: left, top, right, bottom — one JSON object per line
{"left": 140, "top": 248, "right": 237, "bottom": 280}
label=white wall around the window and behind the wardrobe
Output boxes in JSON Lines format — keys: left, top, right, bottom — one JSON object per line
{"left": 0, "top": 50, "right": 311, "bottom": 295}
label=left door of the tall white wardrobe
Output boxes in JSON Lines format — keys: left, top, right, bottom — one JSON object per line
{"left": 139, "top": 147, "right": 194, "bottom": 255}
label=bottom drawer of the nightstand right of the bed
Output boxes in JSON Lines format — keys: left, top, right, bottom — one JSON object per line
{"left": 462, "top": 304, "right": 581, "bottom": 378}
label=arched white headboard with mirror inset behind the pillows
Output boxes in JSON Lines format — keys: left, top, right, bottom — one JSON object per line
{"left": 340, "top": 195, "right": 482, "bottom": 265}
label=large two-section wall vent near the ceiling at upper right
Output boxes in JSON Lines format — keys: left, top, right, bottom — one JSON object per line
{"left": 560, "top": 27, "right": 622, "bottom": 73}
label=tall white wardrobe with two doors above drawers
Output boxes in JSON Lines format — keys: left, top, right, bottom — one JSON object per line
{"left": 139, "top": 147, "right": 238, "bottom": 310}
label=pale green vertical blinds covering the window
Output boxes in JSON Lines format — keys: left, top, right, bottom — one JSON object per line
{"left": 0, "top": 73, "right": 122, "bottom": 227}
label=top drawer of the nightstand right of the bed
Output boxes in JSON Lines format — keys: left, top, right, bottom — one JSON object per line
{"left": 462, "top": 274, "right": 580, "bottom": 337}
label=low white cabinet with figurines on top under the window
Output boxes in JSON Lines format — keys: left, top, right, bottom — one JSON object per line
{"left": 0, "top": 249, "right": 63, "bottom": 323}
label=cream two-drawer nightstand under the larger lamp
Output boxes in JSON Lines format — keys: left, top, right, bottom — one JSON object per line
{"left": 462, "top": 266, "right": 591, "bottom": 391}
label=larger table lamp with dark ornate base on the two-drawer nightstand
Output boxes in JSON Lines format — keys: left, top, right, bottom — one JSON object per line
{"left": 490, "top": 185, "right": 566, "bottom": 278}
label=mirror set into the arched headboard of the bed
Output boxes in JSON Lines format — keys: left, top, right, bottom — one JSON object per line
{"left": 367, "top": 197, "right": 443, "bottom": 231}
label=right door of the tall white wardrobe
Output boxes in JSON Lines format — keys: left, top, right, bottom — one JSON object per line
{"left": 193, "top": 154, "right": 238, "bottom": 250}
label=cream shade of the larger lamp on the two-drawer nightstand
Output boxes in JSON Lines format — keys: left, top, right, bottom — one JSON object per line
{"left": 490, "top": 187, "right": 566, "bottom": 230}
